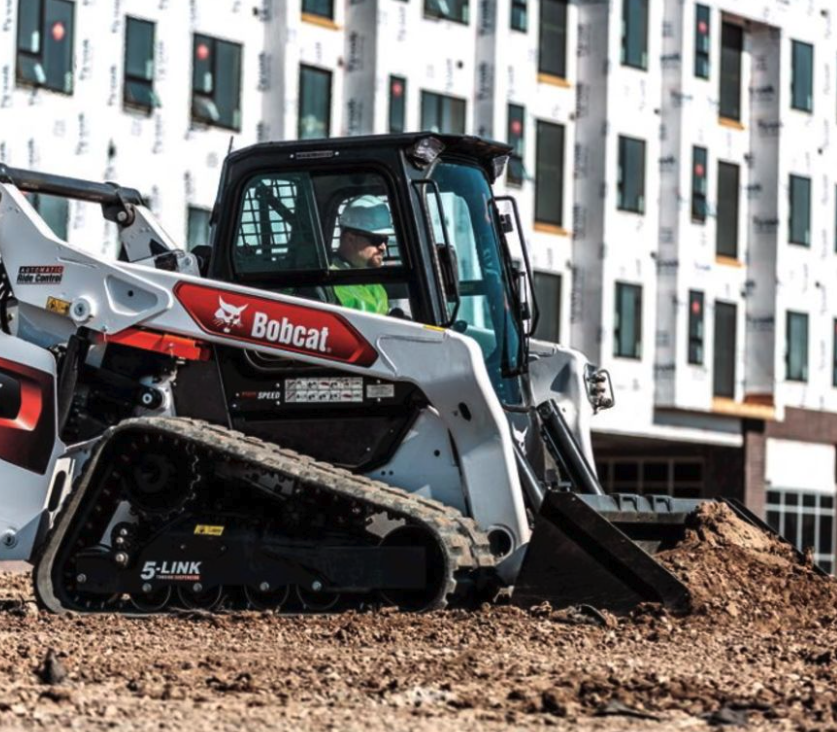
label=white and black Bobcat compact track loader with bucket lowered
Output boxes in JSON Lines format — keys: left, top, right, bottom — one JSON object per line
{"left": 0, "top": 134, "right": 760, "bottom": 613}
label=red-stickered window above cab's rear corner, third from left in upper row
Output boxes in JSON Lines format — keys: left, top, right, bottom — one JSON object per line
{"left": 192, "top": 34, "right": 241, "bottom": 130}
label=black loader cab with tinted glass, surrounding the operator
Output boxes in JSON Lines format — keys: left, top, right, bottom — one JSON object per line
{"left": 202, "top": 133, "right": 527, "bottom": 403}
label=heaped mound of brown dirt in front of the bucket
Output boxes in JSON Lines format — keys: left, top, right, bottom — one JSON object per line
{"left": 657, "top": 503, "right": 837, "bottom": 628}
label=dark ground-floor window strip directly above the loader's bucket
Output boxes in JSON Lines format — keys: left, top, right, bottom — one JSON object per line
{"left": 596, "top": 457, "right": 704, "bottom": 498}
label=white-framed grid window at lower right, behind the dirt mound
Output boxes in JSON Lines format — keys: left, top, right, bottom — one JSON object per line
{"left": 767, "top": 489, "right": 834, "bottom": 574}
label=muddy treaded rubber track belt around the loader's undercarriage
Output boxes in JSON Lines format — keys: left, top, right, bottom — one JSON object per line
{"left": 35, "top": 417, "right": 496, "bottom": 612}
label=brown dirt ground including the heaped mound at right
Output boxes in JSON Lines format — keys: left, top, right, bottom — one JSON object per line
{"left": 0, "top": 506, "right": 837, "bottom": 732}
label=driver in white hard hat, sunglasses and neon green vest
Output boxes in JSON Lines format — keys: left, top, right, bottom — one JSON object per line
{"left": 331, "top": 196, "right": 395, "bottom": 315}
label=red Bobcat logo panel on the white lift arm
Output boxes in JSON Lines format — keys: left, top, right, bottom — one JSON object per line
{"left": 174, "top": 282, "right": 378, "bottom": 366}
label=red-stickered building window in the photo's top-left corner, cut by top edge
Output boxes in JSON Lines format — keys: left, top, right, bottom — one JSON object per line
{"left": 16, "top": 0, "right": 75, "bottom": 94}
